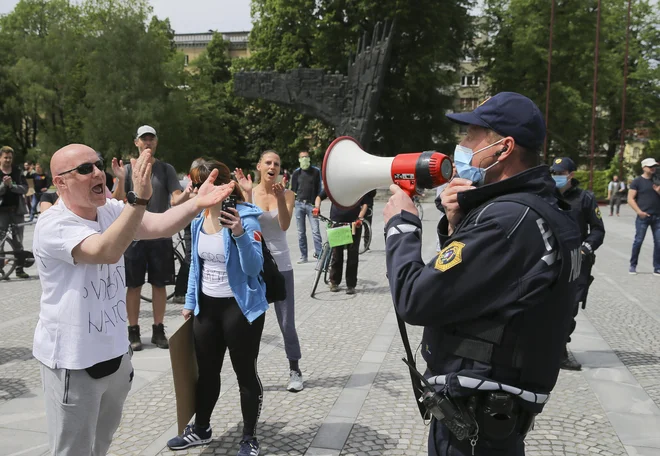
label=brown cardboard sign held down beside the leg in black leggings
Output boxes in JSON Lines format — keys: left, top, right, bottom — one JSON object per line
{"left": 170, "top": 317, "right": 198, "bottom": 435}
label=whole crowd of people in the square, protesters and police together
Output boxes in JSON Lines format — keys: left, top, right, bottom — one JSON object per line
{"left": 0, "top": 92, "right": 660, "bottom": 456}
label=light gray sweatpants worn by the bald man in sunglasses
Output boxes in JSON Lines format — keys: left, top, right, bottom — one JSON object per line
{"left": 41, "top": 353, "right": 133, "bottom": 456}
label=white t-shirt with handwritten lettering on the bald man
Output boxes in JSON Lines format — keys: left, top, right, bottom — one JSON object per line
{"left": 32, "top": 199, "right": 128, "bottom": 369}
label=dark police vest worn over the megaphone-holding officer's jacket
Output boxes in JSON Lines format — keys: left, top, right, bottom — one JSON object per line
{"left": 424, "top": 193, "right": 580, "bottom": 406}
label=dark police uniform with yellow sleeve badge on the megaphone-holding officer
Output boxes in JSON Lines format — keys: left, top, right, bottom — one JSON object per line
{"left": 385, "top": 166, "right": 580, "bottom": 455}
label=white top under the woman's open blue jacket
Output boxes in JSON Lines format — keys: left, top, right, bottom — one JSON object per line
{"left": 197, "top": 229, "right": 234, "bottom": 298}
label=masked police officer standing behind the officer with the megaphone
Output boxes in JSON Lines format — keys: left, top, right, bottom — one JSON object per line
{"left": 551, "top": 157, "right": 605, "bottom": 370}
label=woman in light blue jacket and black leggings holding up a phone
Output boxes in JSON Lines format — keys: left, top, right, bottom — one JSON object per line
{"left": 167, "top": 160, "right": 268, "bottom": 456}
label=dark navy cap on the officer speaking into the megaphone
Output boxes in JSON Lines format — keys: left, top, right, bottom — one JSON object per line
{"left": 447, "top": 92, "right": 545, "bottom": 149}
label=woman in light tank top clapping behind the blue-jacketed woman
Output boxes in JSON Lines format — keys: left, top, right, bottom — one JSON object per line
{"left": 236, "top": 150, "right": 303, "bottom": 392}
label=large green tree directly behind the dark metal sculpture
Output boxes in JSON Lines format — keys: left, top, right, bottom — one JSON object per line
{"left": 236, "top": 0, "right": 471, "bottom": 162}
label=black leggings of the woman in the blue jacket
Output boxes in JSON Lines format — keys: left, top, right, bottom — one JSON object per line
{"left": 193, "top": 293, "right": 266, "bottom": 436}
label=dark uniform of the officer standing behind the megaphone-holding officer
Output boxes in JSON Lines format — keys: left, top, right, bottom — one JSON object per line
{"left": 562, "top": 179, "right": 605, "bottom": 342}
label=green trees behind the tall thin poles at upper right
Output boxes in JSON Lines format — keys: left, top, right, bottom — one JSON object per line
{"left": 478, "top": 0, "right": 660, "bottom": 166}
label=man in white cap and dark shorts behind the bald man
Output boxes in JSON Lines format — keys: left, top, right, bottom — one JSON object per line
{"left": 114, "top": 125, "right": 190, "bottom": 351}
